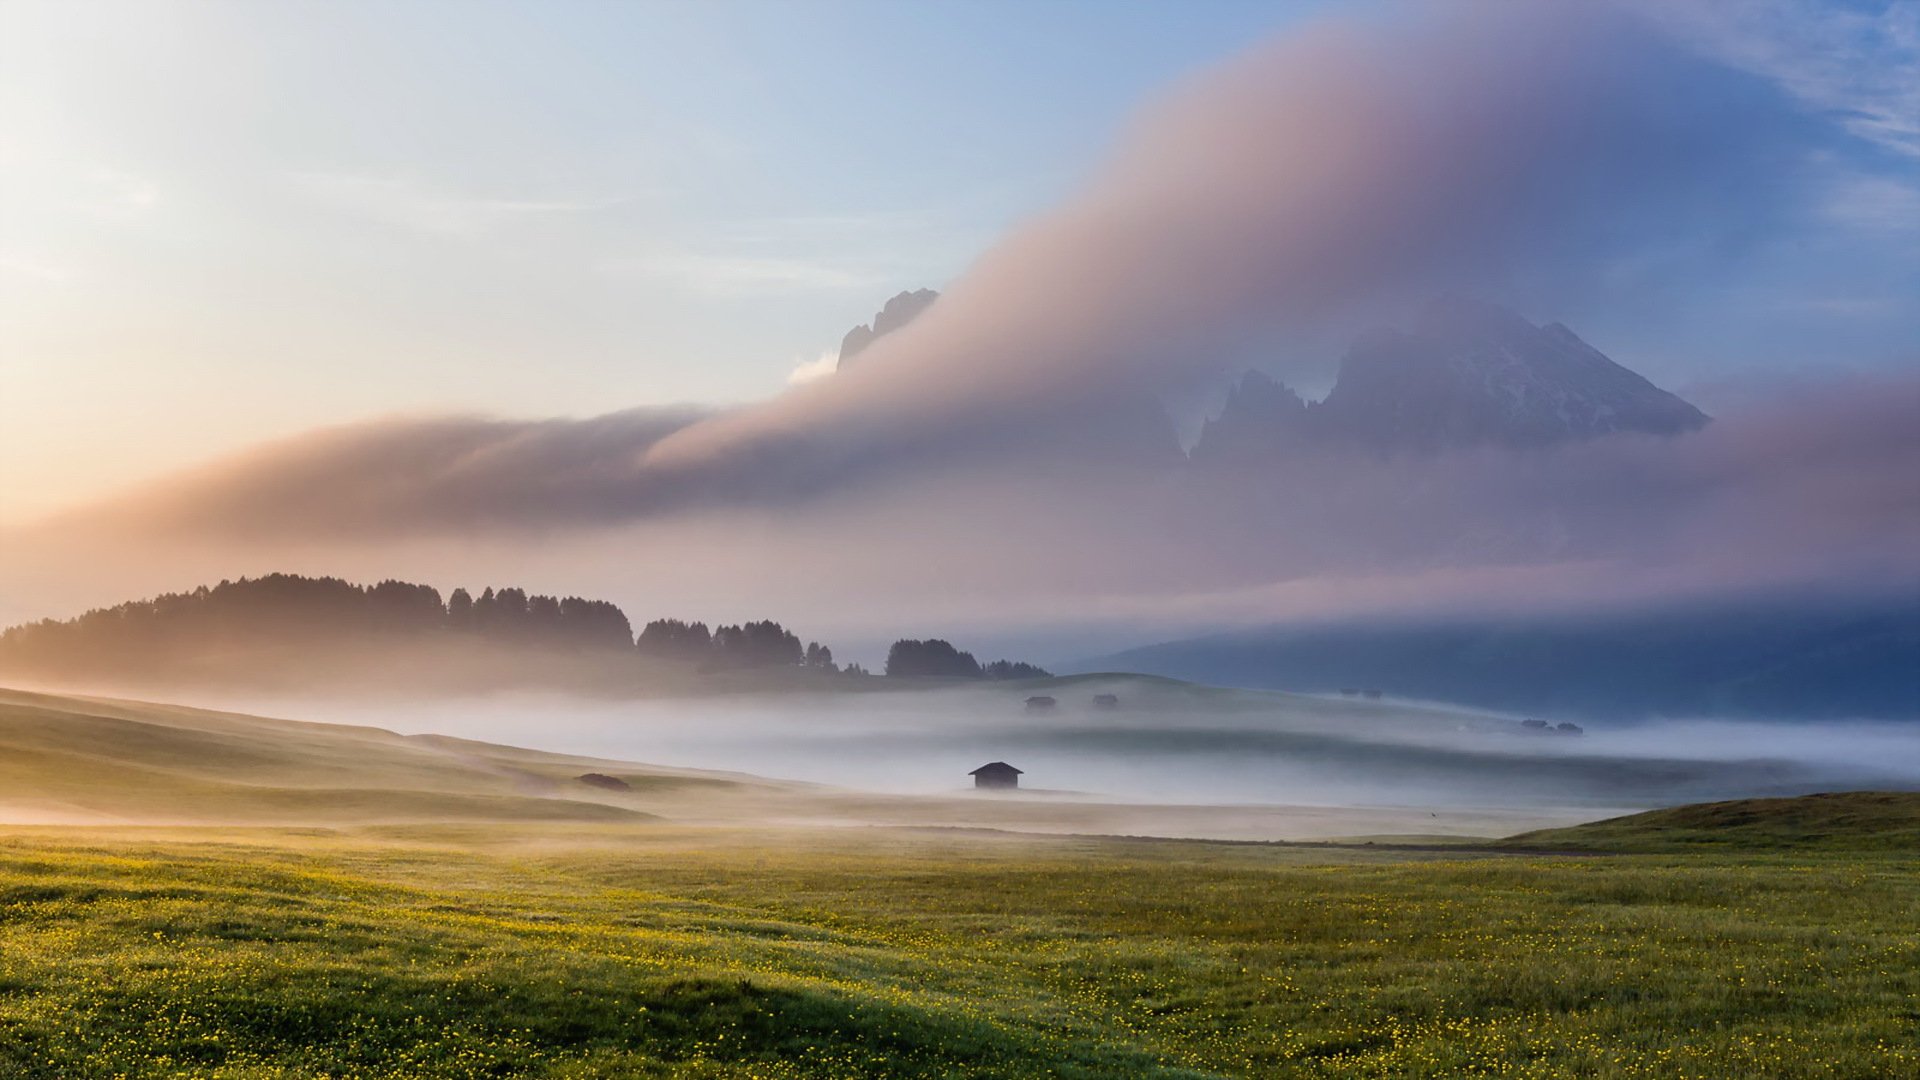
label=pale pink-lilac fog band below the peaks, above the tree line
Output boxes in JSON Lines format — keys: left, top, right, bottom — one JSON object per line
{"left": 15, "top": 365, "right": 1920, "bottom": 665}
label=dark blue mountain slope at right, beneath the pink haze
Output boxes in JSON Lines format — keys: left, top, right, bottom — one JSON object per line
{"left": 1069, "top": 598, "right": 1920, "bottom": 721}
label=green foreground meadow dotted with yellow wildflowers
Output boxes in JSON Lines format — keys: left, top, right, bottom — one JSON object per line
{"left": 0, "top": 810, "right": 1920, "bottom": 1080}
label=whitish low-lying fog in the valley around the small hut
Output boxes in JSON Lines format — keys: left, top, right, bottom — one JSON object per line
{"left": 214, "top": 678, "right": 1920, "bottom": 807}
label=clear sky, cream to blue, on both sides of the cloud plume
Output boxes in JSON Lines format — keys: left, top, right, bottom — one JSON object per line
{"left": 0, "top": 0, "right": 1920, "bottom": 519}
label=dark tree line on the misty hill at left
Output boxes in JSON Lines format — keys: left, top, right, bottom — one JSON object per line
{"left": 0, "top": 575, "right": 1046, "bottom": 678}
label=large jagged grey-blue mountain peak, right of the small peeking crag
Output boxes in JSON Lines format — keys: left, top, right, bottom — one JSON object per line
{"left": 1194, "top": 298, "right": 1707, "bottom": 461}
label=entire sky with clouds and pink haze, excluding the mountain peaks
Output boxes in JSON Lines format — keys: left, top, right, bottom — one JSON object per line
{"left": 0, "top": 2, "right": 1920, "bottom": 655}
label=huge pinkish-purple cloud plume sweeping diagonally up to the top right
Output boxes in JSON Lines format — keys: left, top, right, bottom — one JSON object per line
{"left": 633, "top": 6, "right": 1818, "bottom": 475}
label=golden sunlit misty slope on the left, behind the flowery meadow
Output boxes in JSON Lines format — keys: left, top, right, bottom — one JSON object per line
{"left": 0, "top": 690, "right": 771, "bottom": 824}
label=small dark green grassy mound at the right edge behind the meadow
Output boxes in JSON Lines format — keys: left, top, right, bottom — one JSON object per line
{"left": 1509, "top": 792, "right": 1920, "bottom": 853}
